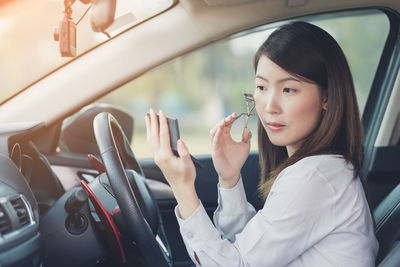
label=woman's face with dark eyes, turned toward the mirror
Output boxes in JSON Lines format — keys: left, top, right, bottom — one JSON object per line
{"left": 254, "top": 56, "right": 327, "bottom": 156}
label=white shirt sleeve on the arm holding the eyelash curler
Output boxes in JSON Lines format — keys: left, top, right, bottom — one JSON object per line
{"left": 213, "top": 177, "right": 256, "bottom": 242}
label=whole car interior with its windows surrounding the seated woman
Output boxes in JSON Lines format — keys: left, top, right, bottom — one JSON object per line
{"left": 0, "top": 0, "right": 400, "bottom": 267}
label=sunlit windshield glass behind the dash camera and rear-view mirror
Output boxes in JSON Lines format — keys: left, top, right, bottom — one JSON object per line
{"left": 0, "top": 0, "right": 173, "bottom": 103}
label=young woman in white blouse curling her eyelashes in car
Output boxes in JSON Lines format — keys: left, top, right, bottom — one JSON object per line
{"left": 146, "top": 22, "right": 378, "bottom": 267}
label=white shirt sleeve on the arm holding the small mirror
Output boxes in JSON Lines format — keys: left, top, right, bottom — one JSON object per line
{"left": 176, "top": 167, "right": 335, "bottom": 267}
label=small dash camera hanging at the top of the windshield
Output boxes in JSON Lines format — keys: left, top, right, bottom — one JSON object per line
{"left": 54, "top": 15, "right": 76, "bottom": 57}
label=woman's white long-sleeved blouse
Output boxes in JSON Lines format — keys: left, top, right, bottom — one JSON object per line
{"left": 175, "top": 155, "right": 378, "bottom": 267}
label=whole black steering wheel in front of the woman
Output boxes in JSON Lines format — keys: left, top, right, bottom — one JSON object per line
{"left": 93, "top": 112, "right": 172, "bottom": 267}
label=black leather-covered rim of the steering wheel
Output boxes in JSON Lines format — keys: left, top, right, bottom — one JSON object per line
{"left": 93, "top": 112, "right": 169, "bottom": 267}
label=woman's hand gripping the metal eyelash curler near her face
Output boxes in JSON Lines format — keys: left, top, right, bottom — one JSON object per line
{"left": 210, "top": 112, "right": 251, "bottom": 188}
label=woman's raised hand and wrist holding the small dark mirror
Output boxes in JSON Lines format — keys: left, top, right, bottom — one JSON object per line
{"left": 145, "top": 109, "right": 199, "bottom": 219}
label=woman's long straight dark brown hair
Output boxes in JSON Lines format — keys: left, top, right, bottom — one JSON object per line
{"left": 254, "top": 22, "right": 363, "bottom": 199}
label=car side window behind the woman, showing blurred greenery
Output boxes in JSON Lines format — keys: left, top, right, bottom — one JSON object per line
{"left": 99, "top": 10, "right": 390, "bottom": 158}
